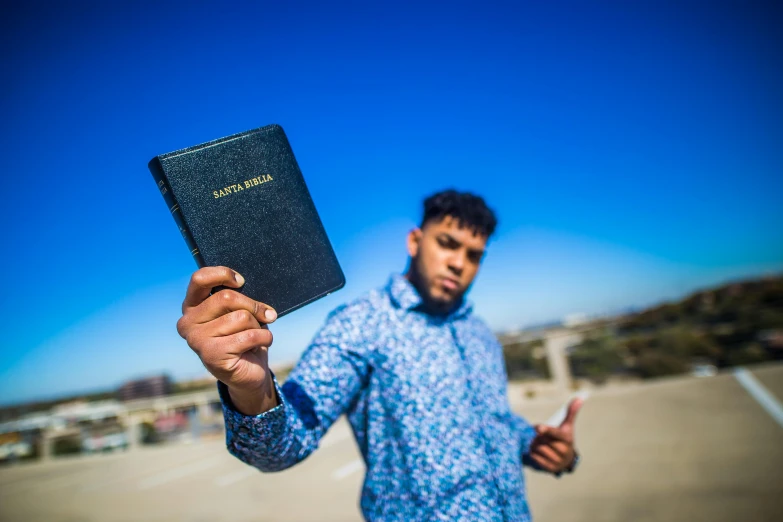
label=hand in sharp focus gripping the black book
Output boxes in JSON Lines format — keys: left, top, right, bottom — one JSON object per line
{"left": 177, "top": 266, "right": 277, "bottom": 415}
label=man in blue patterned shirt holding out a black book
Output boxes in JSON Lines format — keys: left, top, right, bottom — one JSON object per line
{"left": 177, "top": 191, "right": 580, "bottom": 522}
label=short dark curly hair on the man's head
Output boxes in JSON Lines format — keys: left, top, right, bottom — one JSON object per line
{"left": 421, "top": 189, "right": 498, "bottom": 239}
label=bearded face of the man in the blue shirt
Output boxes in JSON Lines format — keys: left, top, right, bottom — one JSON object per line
{"left": 406, "top": 216, "right": 487, "bottom": 313}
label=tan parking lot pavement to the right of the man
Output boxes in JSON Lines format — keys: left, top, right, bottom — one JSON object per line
{"left": 528, "top": 366, "right": 783, "bottom": 522}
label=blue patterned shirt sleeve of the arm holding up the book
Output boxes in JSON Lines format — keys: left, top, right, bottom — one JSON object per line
{"left": 218, "top": 300, "right": 368, "bottom": 471}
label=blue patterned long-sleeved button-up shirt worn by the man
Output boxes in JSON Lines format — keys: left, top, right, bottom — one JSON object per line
{"left": 218, "top": 275, "right": 535, "bottom": 522}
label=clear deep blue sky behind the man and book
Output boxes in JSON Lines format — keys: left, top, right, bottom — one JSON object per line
{"left": 0, "top": 2, "right": 783, "bottom": 403}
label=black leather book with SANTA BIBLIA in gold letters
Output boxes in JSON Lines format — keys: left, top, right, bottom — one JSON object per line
{"left": 149, "top": 125, "right": 345, "bottom": 316}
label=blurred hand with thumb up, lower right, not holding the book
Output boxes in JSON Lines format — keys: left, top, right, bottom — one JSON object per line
{"left": 530, "top": 398, "right": 584, "bottom": 473}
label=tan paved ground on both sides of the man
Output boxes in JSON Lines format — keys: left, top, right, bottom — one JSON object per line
{"left": 0, "top": 365, "right": 783, "bottom": 522}
